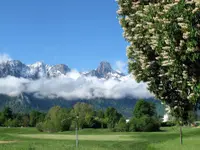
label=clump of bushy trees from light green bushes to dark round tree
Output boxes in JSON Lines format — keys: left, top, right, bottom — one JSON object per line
{"left": 36, "top": 100, "right": 160, "bottom": 132}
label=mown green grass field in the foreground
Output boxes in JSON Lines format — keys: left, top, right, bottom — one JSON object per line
{"left": 0, "top": 127, "right": 200, "bottom": 150}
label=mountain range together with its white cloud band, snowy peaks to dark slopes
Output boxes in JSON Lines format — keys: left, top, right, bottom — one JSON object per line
{"left": 0, "top": 60, "right": 164, "bottom": 116}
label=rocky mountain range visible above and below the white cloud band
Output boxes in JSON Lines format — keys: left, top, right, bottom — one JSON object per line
{"left": 0, "top": 60, "right": 164, "bottom": 117}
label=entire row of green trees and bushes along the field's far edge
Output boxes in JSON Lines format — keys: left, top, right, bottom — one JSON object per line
{"left": 0, "top": 100, "right": 160, "bottom": 132}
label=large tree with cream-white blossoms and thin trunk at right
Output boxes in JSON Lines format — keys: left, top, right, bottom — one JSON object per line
{"left": 117, "top": 0, "right": 200, "bottom": 144}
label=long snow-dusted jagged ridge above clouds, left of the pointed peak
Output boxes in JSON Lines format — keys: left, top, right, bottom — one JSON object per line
{"left": 0, "top": 60, "right": 70, "bottom": 79}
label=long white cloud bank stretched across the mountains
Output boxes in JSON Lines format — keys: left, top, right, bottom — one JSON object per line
{"left": 0, "top": 71, "right": 152, "bottom": 100}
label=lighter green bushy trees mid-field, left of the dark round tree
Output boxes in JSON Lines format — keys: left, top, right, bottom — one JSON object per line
{"left": 37, "top": 103, "right": 125, "bottom": 132}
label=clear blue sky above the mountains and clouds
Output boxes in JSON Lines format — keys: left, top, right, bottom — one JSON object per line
{"left": 0, "top": 0, "right": 127, "bottom": 71}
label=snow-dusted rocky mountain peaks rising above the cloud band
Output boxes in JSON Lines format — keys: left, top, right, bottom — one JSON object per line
{"left": 0, "top": 60, "right": 125, "bottom": 80}
